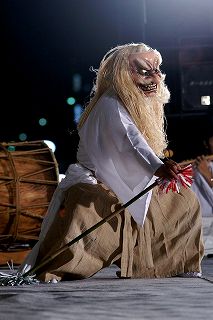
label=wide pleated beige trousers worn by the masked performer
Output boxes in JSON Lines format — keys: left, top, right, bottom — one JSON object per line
{"left": 36, "top": 183, "right": 204, "bottom": 281}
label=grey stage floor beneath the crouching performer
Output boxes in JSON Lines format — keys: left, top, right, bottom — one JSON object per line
{"left": 0, "top": 258, "right": 213, "bottom": 320}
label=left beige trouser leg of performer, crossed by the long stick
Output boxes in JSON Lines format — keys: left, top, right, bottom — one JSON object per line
{"left": 36, "top": 183, "right": 123, "bottom": 281}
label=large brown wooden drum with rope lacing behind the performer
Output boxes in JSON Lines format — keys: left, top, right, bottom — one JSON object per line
{"left": 0, "top": 141, "right": 59, "bottom": 264}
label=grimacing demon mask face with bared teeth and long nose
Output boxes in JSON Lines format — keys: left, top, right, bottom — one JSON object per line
{"left": 129, "top": 50, "right": 162, "bottom": 96}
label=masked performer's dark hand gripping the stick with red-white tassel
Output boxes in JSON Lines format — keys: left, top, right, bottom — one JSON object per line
{"left": 155, "top": 160, "right": 181, "bottom": 180}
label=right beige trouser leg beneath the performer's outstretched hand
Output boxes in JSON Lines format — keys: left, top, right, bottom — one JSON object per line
{"left": 132, "top": 188, "right": 204, "bottom": 278}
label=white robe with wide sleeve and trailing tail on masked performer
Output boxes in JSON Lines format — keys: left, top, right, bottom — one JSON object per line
{"left": 21, "top": 92, "right": 163, "bottom": 269}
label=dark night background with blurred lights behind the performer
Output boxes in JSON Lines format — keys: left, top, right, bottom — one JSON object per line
{"left": 0, "top": 0, "right": 213, "bottom": 173}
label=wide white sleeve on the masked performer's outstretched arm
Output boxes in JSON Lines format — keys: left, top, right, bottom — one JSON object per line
{"left": 100, "top": 99, "right": 163, "bottom": 191}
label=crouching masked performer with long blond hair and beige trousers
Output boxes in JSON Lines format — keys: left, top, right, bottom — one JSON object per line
{"left": 20, "top": 43, "right": 203, "bottom": 281}
